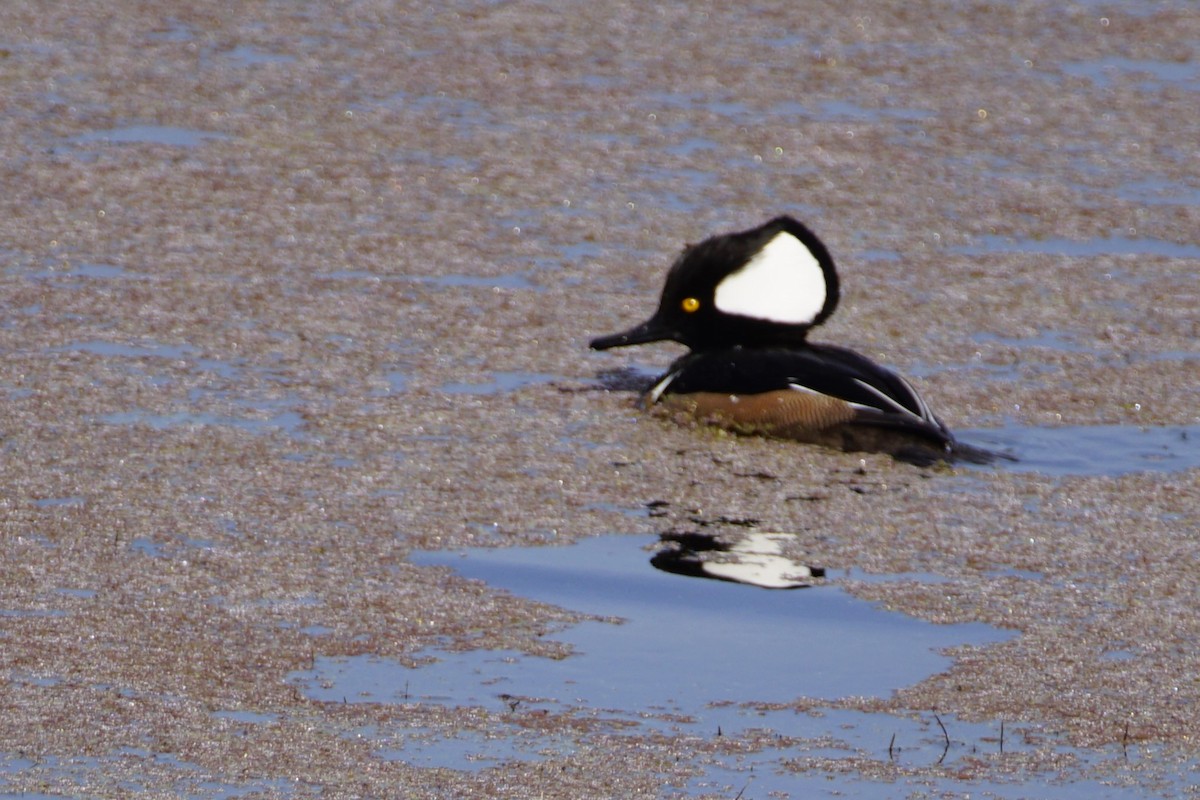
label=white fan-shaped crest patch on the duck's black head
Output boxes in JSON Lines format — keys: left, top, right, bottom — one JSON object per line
{"left": 713, "top": 231, "right": 826, "bottom": 325}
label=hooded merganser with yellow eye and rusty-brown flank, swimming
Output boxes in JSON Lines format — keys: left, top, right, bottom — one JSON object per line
{"left": 592, "top": 216, "right": 995, "bottom": 464}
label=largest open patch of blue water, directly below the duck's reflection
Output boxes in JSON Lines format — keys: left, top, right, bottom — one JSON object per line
{"left": 293, "top": 536, "right": 1012, "bottom": 729}
